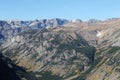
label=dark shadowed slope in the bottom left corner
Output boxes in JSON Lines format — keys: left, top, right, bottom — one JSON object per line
{"left": 0, "top": 53, "right": 37, "bottom": 80}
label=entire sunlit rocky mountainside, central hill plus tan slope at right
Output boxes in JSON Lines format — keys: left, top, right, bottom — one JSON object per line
{"left": 0, "top": 19, "right": 120, "bottom": 80}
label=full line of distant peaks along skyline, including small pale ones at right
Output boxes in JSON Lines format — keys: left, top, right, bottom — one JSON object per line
{"left": 0, "top": 18, "right": 119, "bottom": 39}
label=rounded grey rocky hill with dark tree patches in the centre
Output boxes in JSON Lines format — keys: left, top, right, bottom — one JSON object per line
{"left": 2, "top": 29, "right": 95, "bottom": 77}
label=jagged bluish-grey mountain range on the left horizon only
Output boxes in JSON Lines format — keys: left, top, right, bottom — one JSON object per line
{"left": 0, "top": 18, "right": 69, "bottom": 38}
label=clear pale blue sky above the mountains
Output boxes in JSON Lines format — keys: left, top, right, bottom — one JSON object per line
{"left": 0, "top": 0, "right": 120, "bottom": 20}
